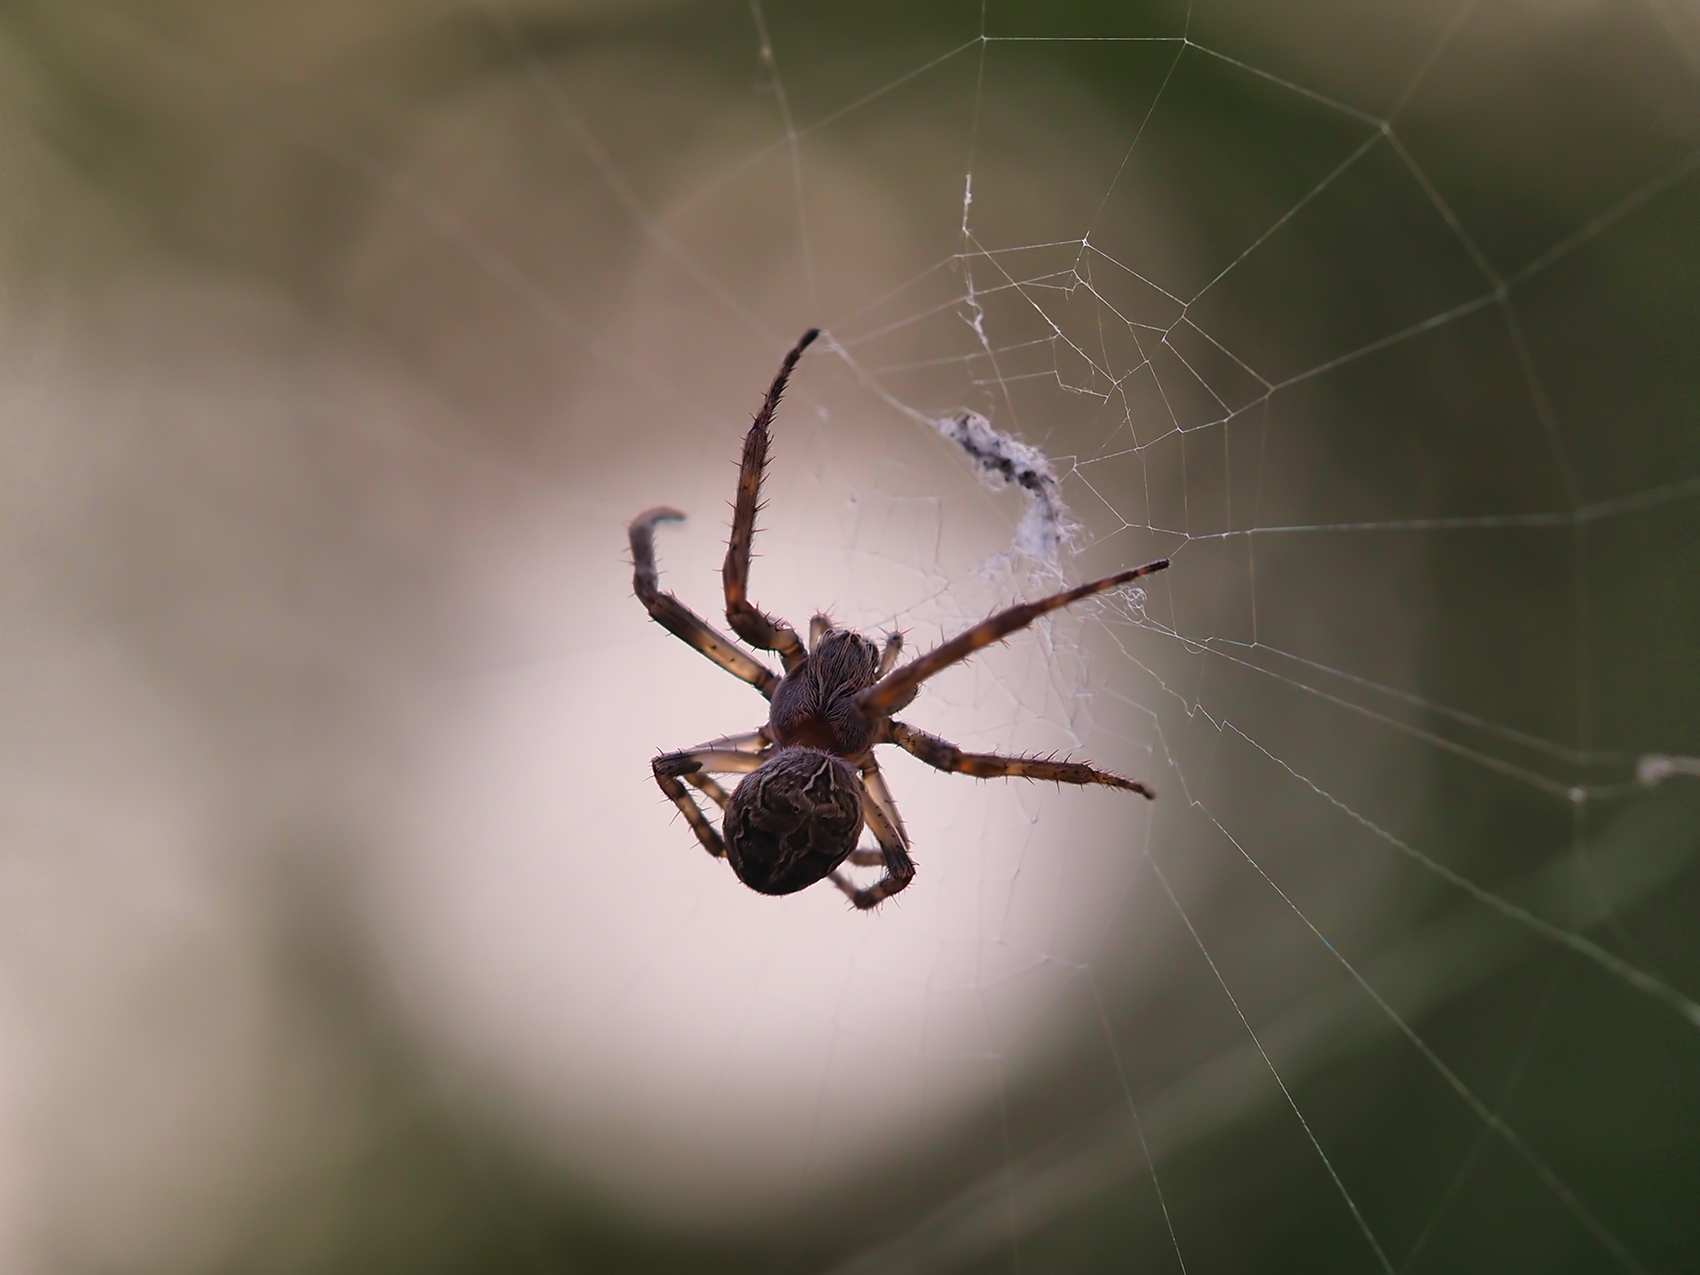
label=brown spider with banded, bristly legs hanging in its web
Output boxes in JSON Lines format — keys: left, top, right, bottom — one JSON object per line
{"left": 629, "top": 328, "right": 1168, "bottom": 910}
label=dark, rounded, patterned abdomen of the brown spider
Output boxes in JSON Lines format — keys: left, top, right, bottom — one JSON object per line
{"left": 724, "top": 748, "right": 862, "bottom": 894}
